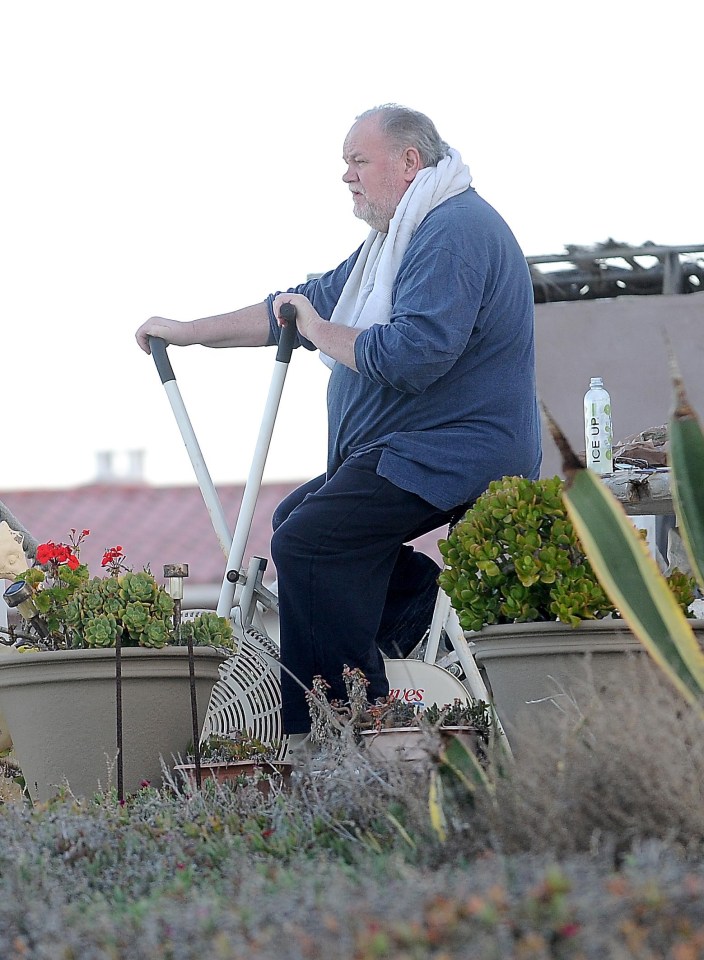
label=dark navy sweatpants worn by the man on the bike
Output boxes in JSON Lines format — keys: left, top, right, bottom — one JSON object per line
{"left": 271, "top": 450, "right": 457, "bottom": 733}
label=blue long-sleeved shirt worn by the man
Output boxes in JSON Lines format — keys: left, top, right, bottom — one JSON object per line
{"left": 268, "top": 188, "right": 541, "bottom": 510}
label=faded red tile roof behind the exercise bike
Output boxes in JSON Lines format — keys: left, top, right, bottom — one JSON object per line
{"left": 0, "top": 482, "right": 444, "bottom": 586}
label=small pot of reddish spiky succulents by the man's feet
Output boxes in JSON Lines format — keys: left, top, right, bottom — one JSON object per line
{"left": 308, "top": 666, "right": 493, "bottom": 760}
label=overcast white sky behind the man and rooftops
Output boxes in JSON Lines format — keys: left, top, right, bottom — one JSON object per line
{"left": 0, "top": 0, "right": 704, "bottom": 491}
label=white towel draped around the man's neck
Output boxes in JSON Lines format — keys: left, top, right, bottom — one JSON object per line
{"left": 320, "top": 149, "right": 472, "bottom": 370}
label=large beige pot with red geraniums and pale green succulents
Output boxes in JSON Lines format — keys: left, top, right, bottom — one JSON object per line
{"left": 0, "top": 530, "right": 233, "bottom": 800}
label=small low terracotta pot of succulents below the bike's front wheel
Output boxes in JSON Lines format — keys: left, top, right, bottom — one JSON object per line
{"left": 174, "top": 730, "right": 291, "bottom": 794}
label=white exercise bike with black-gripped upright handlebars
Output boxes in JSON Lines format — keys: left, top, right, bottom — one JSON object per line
{"left": 150, "top": 304, "right": 500, "bottom": 759}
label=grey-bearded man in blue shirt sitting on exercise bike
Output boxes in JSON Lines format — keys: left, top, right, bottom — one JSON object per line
{"left": 137, "top": 104, "right": 541, "bottom": 734}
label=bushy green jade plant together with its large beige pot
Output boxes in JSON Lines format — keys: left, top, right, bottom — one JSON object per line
{"left": 439, "top": 477, "right": 695, "bottom": 733}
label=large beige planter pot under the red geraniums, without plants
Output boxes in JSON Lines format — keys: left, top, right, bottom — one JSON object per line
{"left": 0, "top": 647, "right": 223, "bottom": 800}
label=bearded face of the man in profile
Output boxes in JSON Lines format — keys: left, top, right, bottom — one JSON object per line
{"left": 342, "top": 116, "right": 417, "bottom": 233}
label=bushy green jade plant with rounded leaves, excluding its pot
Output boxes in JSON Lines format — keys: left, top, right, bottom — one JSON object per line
{"left": 438, "top": 477, "right": 695, "bottom": 630}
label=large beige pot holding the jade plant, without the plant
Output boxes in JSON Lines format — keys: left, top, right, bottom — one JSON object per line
{"left": 466, "top": 619, "right": 704, "bottom": 736}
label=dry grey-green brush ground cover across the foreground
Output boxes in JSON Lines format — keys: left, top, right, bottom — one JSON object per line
{"left": 0, "top": 656, "right": 704, "bottom": 960}
